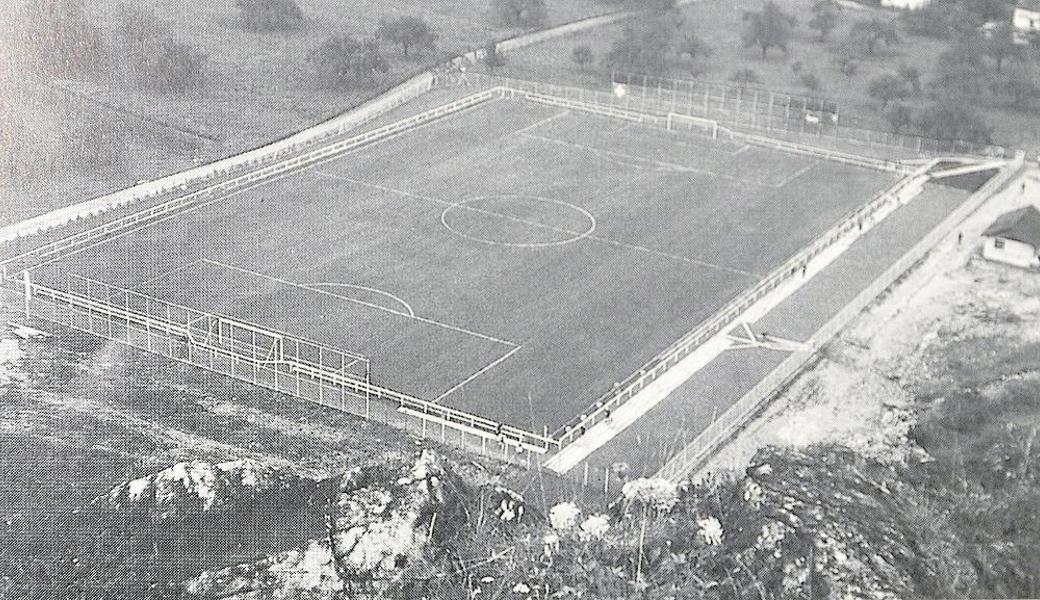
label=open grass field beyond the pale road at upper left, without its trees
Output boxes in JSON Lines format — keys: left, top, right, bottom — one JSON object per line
{"left": 0, "top": 0, "right": 613, "bottom": 225}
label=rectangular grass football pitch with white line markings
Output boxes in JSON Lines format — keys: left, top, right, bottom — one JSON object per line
{"left": 40, "top": 100, "right": 896, "bottom": 432}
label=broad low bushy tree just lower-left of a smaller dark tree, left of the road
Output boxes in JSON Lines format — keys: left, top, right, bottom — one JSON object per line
{"left": 307, "top": 35, "right": 390, "bottom": 87}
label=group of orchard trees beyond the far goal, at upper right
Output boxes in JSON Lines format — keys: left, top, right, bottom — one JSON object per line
{"left": 570, "top": 0, "right": 1040, "bottom": 141}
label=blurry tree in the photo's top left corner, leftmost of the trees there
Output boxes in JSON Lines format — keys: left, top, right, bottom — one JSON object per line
{"left": 25, "top": 0, "right": 104, "bottom": 78}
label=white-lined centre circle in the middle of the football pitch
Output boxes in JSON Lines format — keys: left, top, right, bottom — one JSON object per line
{"left": 441, "top": 194, "right": 596, "bottom": 247}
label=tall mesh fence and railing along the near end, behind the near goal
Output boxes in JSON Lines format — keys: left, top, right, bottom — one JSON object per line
{"left": 0, "top": 267, "right": 554, "bottom": 462}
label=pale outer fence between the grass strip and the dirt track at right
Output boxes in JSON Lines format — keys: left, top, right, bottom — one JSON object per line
{"left": 656, "top": 157, "right": 1022, "bottom": 482}
